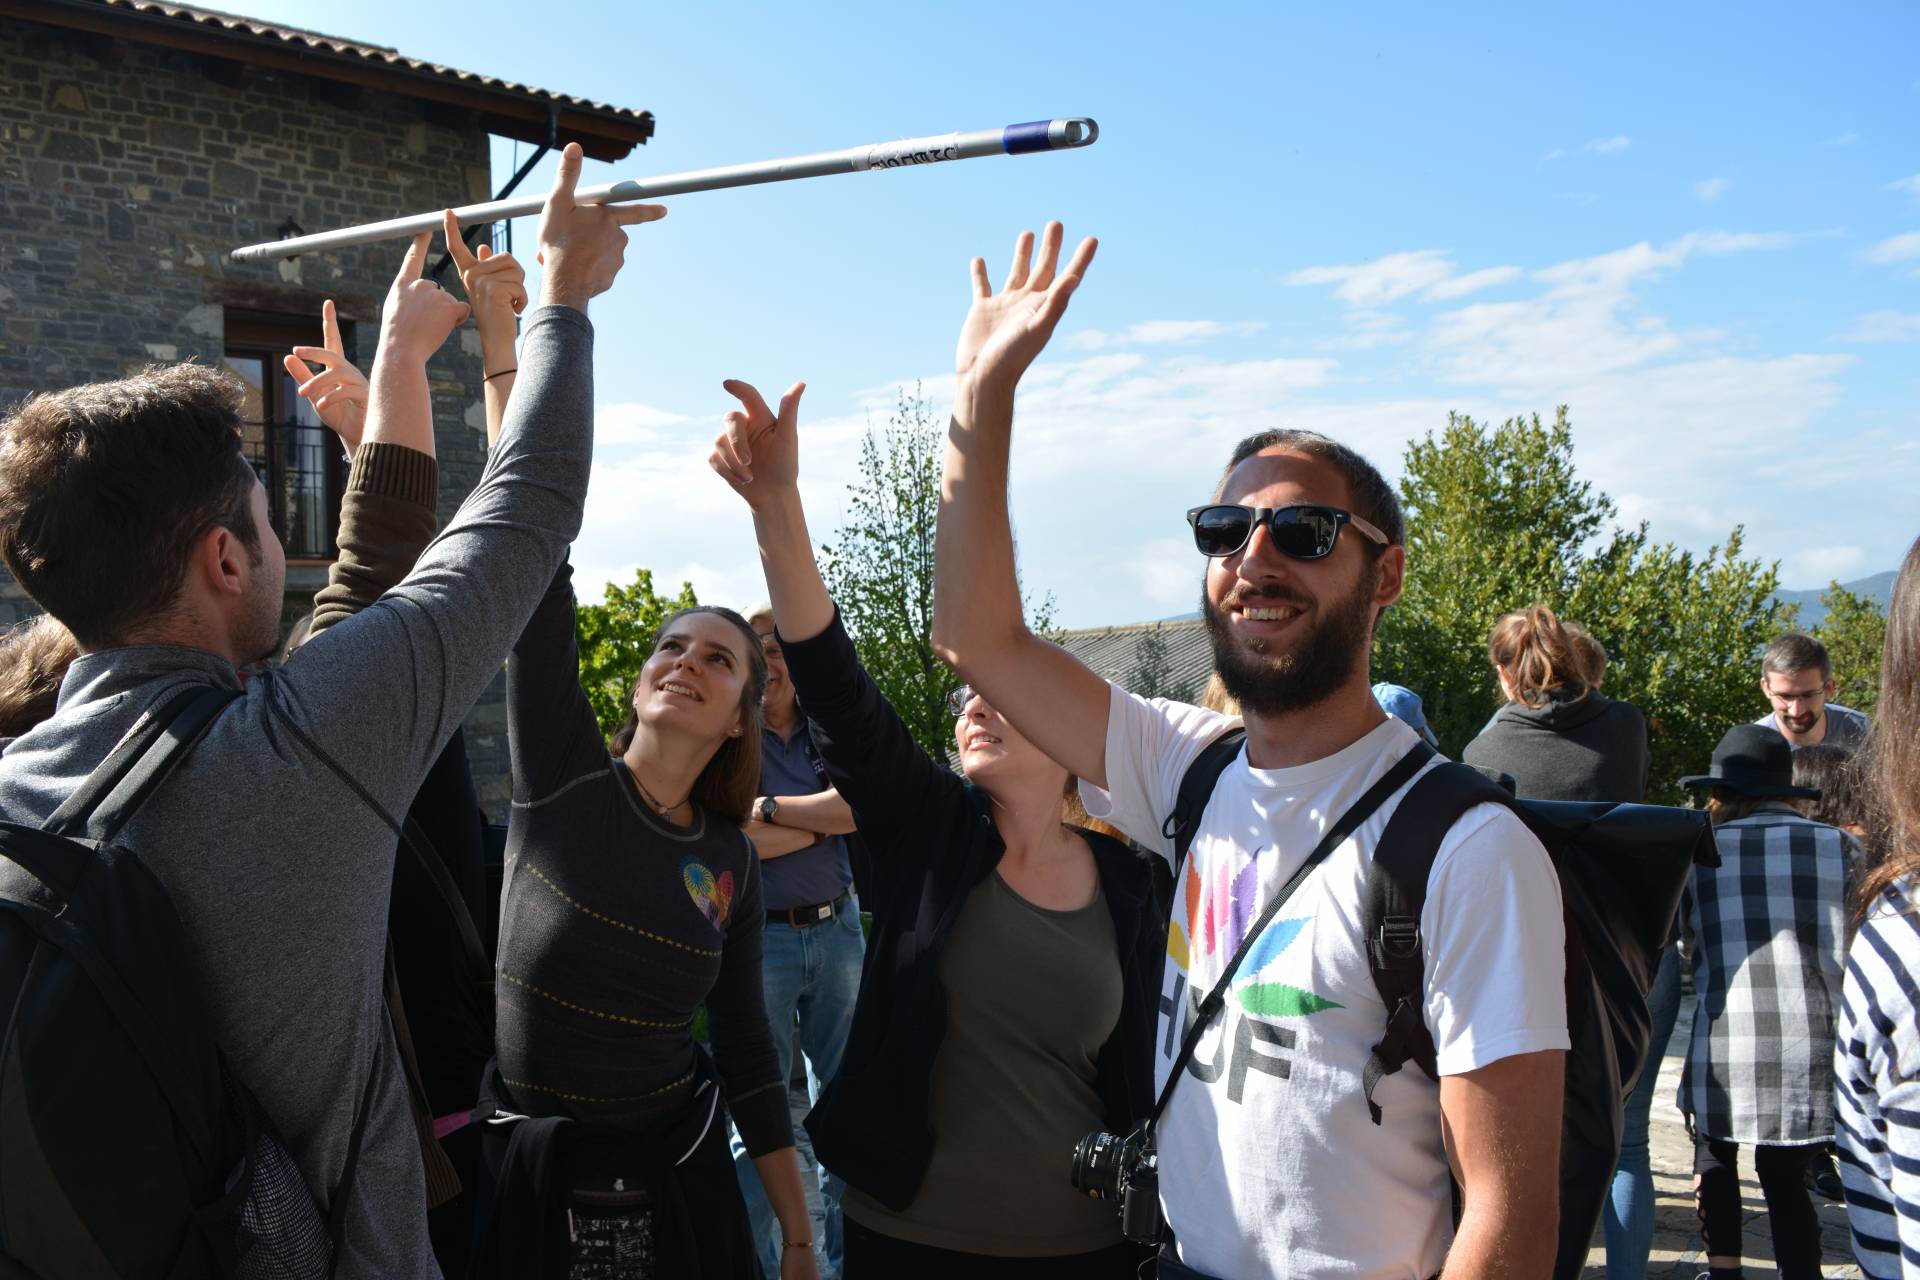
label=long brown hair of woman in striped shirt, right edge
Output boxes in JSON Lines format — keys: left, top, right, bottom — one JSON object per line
{"left": 1860, "top": 539, "right": 1920, "bottom": 913}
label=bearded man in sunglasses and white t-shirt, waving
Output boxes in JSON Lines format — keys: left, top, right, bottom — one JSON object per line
{"left": 933, "top": 223, "right": 1569, "bottom": 1280}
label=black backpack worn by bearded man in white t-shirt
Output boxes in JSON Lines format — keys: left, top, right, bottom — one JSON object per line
{"left": 1167, "top": 729, "right": 1718, "bottom": 1280}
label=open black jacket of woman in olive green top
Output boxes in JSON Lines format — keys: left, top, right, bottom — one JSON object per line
{"left": 780, "top": 612, "right": 1167, "bottom": 1211}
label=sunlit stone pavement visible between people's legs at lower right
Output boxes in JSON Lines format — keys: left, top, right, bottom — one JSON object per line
{"left": 1586, "top": 996, "right": 1860, "bottom": 1280}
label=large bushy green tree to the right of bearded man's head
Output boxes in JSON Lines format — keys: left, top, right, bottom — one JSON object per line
{"left": 1375, "top": 407, "right": 1791, "bottom": 802}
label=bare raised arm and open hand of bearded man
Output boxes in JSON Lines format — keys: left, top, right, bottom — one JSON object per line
{"left": 933, "top": 223, "right": 1110, "bottom": 787}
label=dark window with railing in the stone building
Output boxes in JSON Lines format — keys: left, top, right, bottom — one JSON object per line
{"left": 227, "top": 309, "right": 353, "bottom": 560}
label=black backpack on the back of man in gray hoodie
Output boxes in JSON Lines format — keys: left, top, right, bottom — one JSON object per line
{"left": 0, "top": 687, "right": 372, "bottom": 1280}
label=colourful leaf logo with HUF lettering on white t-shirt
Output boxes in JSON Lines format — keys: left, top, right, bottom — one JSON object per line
{"left": 1160, "top": 850, "right": 1340, "bottom": 1102}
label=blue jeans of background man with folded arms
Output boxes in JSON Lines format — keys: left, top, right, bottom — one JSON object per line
{"left": 733, "top": 894, "right": 866, "bottom": 1280}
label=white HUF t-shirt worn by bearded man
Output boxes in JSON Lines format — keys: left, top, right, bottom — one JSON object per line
{"left": 1081, "top": 687, "right": 1567, "bottom": 1280}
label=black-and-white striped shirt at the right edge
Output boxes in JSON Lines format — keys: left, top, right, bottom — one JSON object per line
{"left": 1834, "top": 881, "right": 1920, "bottom": 1280}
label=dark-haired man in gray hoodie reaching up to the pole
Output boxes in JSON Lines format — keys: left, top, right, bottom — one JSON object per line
{"left": 0, "top": 146, "right": 664, "bottom": 1278}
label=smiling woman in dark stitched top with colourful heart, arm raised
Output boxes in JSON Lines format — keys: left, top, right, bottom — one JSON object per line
{"left": 492, "top": 566, "right": 814, "bottom": 1280}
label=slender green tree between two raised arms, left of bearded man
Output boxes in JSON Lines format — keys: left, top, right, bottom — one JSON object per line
{"left": 820, "top": 386, "right": 1052, "bottom": 760}
